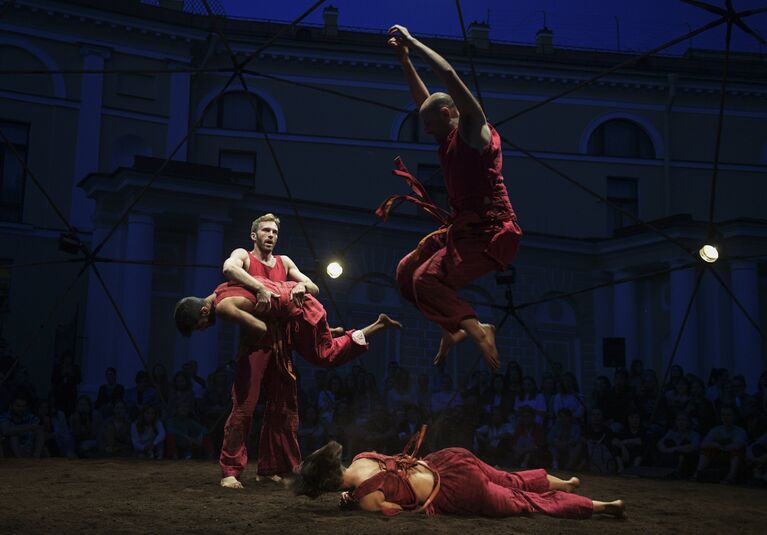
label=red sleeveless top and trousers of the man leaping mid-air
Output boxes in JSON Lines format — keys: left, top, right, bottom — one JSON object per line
{"left": 390, "top": 126, "right": 522, "bottom": 332}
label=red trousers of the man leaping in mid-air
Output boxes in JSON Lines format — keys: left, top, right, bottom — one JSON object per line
{"left": 397, "top": 214, "right": 522, "bottom": 332}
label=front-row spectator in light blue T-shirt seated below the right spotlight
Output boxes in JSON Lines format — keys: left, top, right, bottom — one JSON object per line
{"left": 693, "top": 406, "right": 747, "bottom": 483}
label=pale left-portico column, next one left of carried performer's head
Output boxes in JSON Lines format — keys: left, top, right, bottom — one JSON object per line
{"left": 118, "top": 212, "right": 154, "bottom": 386}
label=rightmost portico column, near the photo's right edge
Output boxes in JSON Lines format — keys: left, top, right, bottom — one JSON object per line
{"left": 730, "top": 260, "right": 765, "bottom": 392}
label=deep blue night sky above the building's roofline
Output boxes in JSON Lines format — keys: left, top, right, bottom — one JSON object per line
{"left": 219, "top": 0, "right": 767, "bottom": 54}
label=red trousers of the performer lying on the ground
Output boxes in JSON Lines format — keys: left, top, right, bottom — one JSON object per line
{"left": 424, "top": 448, "right": 594, "bottom": 518}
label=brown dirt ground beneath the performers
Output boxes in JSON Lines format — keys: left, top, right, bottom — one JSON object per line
{"left": 0, "top": 459, "right": 767, "bottom": 535}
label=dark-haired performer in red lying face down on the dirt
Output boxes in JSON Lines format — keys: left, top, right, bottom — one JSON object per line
{"left": 292, "top": 442, "right": 625, "bottom": 518}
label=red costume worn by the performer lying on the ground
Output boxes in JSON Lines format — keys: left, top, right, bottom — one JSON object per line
{"left": 353, "top": 448, "right": 594, "bottom": 518}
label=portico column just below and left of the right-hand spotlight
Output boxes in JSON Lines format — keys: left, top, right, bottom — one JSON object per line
{"left": 664, "top": 268, "right": 705, "bottom": 376}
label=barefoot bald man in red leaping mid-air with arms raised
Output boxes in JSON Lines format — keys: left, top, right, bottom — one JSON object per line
{"left": 377, "top": 25, "right": 522, "bottom": 369}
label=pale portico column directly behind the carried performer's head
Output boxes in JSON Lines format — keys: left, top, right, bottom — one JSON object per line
{"left": 182, "top": 220, "right": 224, "bottom": 377}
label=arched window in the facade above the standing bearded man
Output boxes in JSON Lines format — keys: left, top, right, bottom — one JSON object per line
{"left": 202, "top": 91, "right": 277, "bottom": 132}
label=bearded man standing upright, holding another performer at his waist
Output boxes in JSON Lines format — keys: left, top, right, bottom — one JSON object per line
{"left": 219, "top": 214, "right": 319, "bottom": 488}
